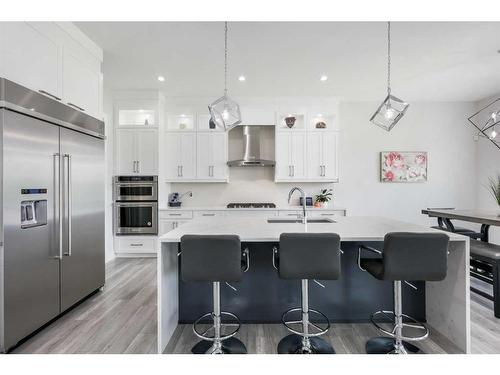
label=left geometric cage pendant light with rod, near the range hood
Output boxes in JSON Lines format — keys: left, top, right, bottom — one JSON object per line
{"left": 208, "top": 22, "right": 241, "bottom": 131}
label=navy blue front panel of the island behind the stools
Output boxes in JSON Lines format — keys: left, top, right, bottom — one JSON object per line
{"left": 179, "top": 242, "right": 425, "bottom": 323}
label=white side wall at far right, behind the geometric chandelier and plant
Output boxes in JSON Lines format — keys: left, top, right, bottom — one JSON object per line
{"left": 475, "top": 93, "right": 500, "bottom": 244}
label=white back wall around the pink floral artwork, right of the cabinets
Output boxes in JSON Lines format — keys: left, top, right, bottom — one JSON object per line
{"left": 336, "top": 102, "right": 476, "bottom": 225}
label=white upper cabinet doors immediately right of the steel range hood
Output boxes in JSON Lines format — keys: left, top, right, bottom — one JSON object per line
{"left": 275, "top": 132, "right": 307, "bottom": 181}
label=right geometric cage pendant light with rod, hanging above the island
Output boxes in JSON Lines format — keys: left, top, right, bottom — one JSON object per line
{"left": 370, "top": 22, "right": 409, "bottom": 131}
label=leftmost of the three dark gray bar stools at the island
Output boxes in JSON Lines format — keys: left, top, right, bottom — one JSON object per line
{"left": 179, "top": 235, "right": 250, "bottom": 354}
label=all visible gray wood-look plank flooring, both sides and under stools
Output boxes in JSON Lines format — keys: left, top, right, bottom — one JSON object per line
{"left": 13, "top": 259, "right": 500, "bottom": 353}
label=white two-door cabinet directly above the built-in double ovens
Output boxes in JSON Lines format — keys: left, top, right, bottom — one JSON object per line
{"left": 116, "top": 128, "right": 158, "bottom": 175}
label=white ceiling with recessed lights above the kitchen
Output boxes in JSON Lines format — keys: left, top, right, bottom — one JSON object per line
{"left": 76, "top": 22, "right": 500, "bottom": 101}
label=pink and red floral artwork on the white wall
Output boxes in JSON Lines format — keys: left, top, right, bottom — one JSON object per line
{"left": 380, "top": 151, "right": 427, "bottom": 182}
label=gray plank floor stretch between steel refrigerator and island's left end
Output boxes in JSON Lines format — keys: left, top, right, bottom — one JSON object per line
{"left": 13, "top": 258, "right": 157, "bottom": 353}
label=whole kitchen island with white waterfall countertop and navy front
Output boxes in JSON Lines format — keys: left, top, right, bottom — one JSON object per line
{"left": 158, "top": 217, "right": 470, "bottom": 353}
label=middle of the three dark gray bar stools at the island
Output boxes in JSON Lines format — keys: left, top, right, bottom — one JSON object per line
{"left": 273, "top": 233, "right": 341, "bottom": 354}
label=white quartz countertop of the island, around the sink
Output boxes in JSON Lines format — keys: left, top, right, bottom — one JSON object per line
{"left": 159, "top": 215, "right": 469, "bottom": 242}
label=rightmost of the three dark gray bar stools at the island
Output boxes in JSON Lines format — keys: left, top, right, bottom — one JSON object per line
{"left": 358, "top": 232, "right": 449, "bottom": 354}
